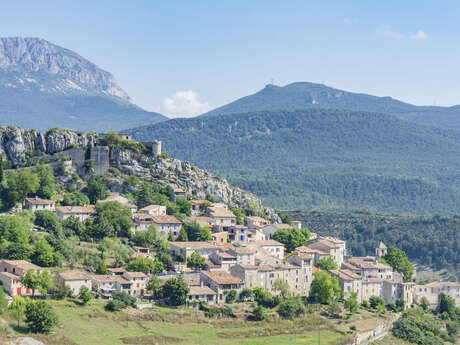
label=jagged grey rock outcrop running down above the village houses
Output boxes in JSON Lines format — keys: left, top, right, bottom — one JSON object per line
{"left": 0, "top": 127, "right": 280, "bottom": 222}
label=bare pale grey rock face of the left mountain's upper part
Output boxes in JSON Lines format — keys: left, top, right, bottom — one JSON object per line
{"left": 0, "top": 37, "right": 129, "bottom": 101}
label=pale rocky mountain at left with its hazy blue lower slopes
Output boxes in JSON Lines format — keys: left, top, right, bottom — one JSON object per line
{"left": 0, "top": 37, "right": 167, "bottom": 131}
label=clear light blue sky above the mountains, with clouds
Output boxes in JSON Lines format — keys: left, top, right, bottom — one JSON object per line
{"left": 0, "top": 0, "right": 460, "bottom": 116}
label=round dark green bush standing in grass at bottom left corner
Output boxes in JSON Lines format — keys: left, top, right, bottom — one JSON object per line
{"left": 25, "top": 300, "right": 58, "bottom": 333}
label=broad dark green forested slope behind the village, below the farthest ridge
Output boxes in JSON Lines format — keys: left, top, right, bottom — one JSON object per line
{"left": 129, "top": 109, "right": 460, "bottom": 214}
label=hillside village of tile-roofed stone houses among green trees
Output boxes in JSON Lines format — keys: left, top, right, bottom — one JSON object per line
{"left": 0, "top": 130, "right": 460, "bottom": 342}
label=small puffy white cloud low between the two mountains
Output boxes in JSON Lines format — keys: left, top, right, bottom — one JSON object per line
{"left": 163, "top": 90, "right": 211, "bottom": 117}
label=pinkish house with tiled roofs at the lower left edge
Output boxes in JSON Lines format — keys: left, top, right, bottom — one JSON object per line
{"left": 0, "top": 260, "right": 42, "bottom": 297}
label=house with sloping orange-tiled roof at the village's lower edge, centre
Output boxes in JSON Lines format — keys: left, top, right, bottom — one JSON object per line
{"left": 200, "top": 271, "right": 243, "bottom": 303}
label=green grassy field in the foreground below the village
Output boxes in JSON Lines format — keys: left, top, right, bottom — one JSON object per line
{"left": 0, "top": 301, "right": 356, "bottom": 345}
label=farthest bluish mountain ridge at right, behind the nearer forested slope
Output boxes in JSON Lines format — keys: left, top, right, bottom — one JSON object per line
{"left": 201, "top": 82, "right": 460, "bottom": 130}
